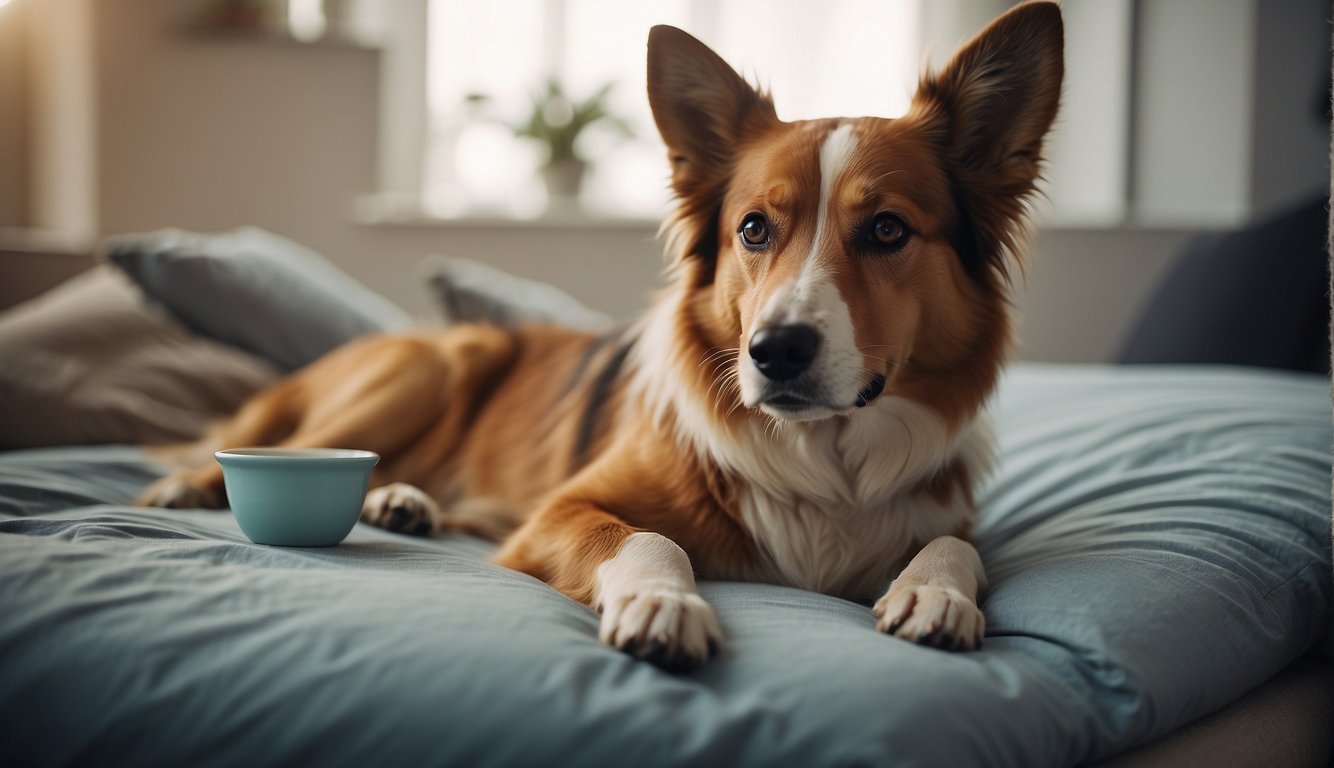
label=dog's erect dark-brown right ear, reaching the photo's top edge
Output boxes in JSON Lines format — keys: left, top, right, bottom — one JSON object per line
{"left": 910, "top": 1, "right": 1065, "bottom": 282}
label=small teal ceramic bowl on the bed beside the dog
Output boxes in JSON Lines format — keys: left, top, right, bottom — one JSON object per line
{"left": 213, "top": 448, "right": 380, "bottom": 547}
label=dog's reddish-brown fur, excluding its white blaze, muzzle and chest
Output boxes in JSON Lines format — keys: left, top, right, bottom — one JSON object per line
{"left": 144, "top": 3, "right": 1062, "bottom": 661}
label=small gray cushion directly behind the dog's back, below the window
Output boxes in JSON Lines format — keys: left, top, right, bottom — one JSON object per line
{"left": 423, "top": 256, "right": 612, "bottom": 331}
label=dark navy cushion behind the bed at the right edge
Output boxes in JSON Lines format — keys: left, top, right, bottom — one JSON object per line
{"left": 1119, "top": 195, "right": 1330, "bottom": 373}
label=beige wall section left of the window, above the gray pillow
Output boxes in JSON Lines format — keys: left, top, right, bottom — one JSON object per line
{"left": 96, "top": 0, "right": 382, "bottom": 290}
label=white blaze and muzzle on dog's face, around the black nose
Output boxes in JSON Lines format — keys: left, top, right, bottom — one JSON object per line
{"left": 740, "top": 123, "right": 863, "bottom": 421}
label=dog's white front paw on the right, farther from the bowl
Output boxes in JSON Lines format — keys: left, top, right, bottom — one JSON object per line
{"left": 871, "top": 581, "right": 986, "bottom": 651}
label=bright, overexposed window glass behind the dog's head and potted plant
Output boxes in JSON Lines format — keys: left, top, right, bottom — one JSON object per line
{"left": 422, "top": 0, "right": 920, "bottom": 217}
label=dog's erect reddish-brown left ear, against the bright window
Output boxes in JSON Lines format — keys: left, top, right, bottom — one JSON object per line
{"left": 648, "top": 25, "right": 778, "bottom": 260}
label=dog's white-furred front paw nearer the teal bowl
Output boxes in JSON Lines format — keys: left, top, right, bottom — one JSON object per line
{"left": 599, "top": 587, "right": 723, "bottom": 671}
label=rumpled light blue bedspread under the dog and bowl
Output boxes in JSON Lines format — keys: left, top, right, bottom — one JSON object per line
{"left": 0, "top": 365, "right": 1331, "bottom": 768}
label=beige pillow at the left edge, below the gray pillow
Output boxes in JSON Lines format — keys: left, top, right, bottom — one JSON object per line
{"left": 0, "top": 267, "right": 277, "bottom": 449}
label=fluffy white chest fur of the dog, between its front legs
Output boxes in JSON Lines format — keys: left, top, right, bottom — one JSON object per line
{"left": 734, "top": 397, "right": 991, "bottom": 597}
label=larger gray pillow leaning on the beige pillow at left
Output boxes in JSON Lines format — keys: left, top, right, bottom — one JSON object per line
{"left": 104, "top": 227, "right": 412, "bottom": 371}
